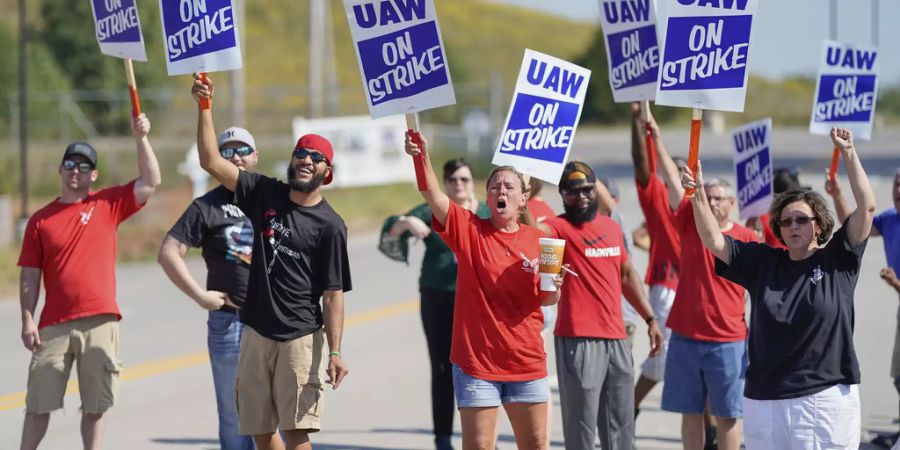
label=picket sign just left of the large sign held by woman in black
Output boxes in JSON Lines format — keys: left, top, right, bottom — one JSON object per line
{"left": 600, "top": 0, "right": 659, "bottom": 103}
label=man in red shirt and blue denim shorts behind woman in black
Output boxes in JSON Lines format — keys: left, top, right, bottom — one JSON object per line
{"left": 662, "top": 154, "right": 759, "bottom": 450}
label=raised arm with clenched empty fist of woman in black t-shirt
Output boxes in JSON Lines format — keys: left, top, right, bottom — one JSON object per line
{"left": 831, "top": 128, "right": 875, "bottom": 247}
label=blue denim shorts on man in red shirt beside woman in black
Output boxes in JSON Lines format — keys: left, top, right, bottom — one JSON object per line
{"left": 662, "top": 332, "right": 747, "bottom": 418}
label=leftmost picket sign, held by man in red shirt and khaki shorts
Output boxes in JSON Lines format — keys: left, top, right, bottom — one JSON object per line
{"left": 91, "top": 0, "right": 147, "bottom": 61}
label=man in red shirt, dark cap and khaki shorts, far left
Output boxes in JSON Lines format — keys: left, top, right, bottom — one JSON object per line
{"left": 18, "top": 114, "right": 160, "bottom": 449}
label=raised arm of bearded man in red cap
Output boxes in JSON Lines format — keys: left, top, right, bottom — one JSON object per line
{"left": 191, "top": 73, "right": 240, "bottom": 192}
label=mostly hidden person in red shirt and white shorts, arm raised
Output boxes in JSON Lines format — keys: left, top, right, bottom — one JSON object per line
{"left": 631, "top": 103, "right": 687, "bottom": 418}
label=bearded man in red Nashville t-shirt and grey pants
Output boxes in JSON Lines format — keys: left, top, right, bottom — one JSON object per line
{"left": 538, "top": 162, "right": 662, "bottom": 450}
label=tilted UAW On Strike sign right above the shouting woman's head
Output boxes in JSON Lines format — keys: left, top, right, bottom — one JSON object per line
{"left": 492, "top": 49, "right": 591, "bottom": 184}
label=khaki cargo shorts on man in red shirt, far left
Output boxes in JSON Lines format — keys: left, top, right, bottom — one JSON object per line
{"left": 25, "top": 314, "right": 122, "bottom": 414}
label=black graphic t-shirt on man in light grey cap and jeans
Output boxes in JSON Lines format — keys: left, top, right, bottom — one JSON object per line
{"left": 169, "top": 186, "right": 253, "bottom": 307}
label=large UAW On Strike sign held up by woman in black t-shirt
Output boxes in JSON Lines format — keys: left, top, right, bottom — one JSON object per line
{"left": 656, "top": 0, "right": 758, "bottom": 111}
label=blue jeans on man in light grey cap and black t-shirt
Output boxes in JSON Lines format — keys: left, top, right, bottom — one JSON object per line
{"left": 206, "top": 311, "right": 254, "bottom": 450}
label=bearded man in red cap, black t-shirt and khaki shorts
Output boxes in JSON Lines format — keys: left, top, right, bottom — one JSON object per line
{"left": 191, "top": 75, "right": 351, "bottom": 450}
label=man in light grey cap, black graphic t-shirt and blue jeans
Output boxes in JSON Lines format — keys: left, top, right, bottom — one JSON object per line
{"left": 157, "top": 127, "right": 259, "bottom": 450}
